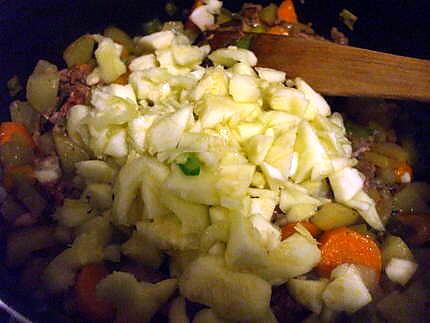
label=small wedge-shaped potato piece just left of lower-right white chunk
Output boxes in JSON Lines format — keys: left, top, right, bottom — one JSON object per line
{"left": 287, "top": 279, "right": 328, "bottom": 314}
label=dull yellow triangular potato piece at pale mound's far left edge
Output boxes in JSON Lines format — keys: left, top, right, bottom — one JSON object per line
{"left": 52, "top": 131, "right": 90, "bottom": 174}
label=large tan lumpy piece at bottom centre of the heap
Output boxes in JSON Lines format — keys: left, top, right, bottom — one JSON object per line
{"left": 179, "top": 256, "right": 271, "bottom": 321}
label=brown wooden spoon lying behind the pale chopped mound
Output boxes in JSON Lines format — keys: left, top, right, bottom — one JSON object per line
{"left": 209, "top": 32, "right": 430, "bottom": 101}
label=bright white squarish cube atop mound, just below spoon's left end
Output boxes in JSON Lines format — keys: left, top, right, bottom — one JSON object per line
{"left": 229, "top": 74, "right": 261, "bottom": 102}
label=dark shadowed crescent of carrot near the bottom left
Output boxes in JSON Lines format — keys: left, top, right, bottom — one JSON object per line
{"left": 75, "top": 264, "right": 115, "bottom": 321}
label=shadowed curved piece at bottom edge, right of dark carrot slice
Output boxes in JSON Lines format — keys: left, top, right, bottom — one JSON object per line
{"left": 96, "top": 272, "right": 177, "bottom": 323}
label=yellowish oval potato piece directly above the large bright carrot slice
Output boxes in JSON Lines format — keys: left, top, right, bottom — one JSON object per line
{"left": 311, "top": 203, "right": 360, "bottom": 231}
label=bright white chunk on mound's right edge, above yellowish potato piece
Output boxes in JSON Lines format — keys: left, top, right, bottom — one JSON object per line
{"left": 329, "top": 167, "right": 364, "bottom": 202}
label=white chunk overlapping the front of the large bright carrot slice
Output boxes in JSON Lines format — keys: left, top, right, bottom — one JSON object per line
{"left": 322, "top": 264, "right": 372, "bottom": 313}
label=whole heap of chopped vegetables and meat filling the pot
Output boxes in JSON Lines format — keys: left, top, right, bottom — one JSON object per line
{"left": 0, "top": 0, "right": 430, "bottom": 322}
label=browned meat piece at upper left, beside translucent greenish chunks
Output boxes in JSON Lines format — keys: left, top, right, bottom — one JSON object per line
{"left": 49, "top": 64, "right": 92, "bottom": 124}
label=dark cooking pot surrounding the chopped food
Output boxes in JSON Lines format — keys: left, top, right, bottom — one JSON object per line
{"left": 0, "top": 0, "right": 430, "bottom": 322}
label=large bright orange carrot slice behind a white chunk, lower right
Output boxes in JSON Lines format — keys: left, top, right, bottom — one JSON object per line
{"left": 317, "top": 227, "right": 382, "bottom": 277}
